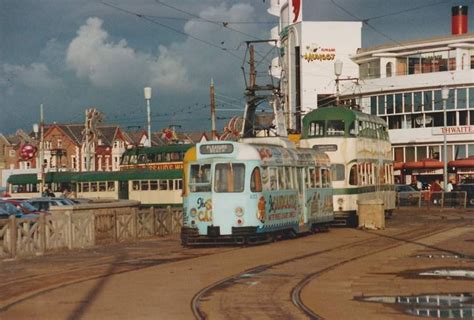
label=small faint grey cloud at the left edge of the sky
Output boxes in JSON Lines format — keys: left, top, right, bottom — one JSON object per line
{"left": 0, "top": 63, "right": 63, "bottom": 90}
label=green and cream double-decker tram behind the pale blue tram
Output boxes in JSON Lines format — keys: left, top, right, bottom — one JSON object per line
{"left": 300, "top": 107, "right": 395, "bottom": 225}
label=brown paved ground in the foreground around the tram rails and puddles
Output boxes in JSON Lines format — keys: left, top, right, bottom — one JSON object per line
{"left": 0, "top": 210, "right": 474, "bottom": 319}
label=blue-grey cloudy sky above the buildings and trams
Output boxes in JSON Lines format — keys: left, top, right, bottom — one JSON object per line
{"left": 0, "top": 0, "right": 474, "bottom": 134}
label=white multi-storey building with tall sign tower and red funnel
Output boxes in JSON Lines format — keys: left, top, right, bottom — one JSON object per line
{"left": 269, "top": 0, "right": 474, "bottom": 183}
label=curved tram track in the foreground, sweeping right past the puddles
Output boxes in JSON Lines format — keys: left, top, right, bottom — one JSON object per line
{"left": 191, "top": 224, "right": 462, "bottom": 319}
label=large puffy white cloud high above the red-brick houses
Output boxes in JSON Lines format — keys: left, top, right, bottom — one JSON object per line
{"left": 66, "top": 18, "right": 190, "bottom": 90}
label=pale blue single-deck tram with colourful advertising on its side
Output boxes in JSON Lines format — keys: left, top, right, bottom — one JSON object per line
{"left": 181, "top": 141, "right": 334, "bottom": 245}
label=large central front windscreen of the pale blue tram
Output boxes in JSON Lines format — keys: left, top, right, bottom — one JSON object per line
{"left": 214, "top": 163, "right": 245, "bottom": 192}
